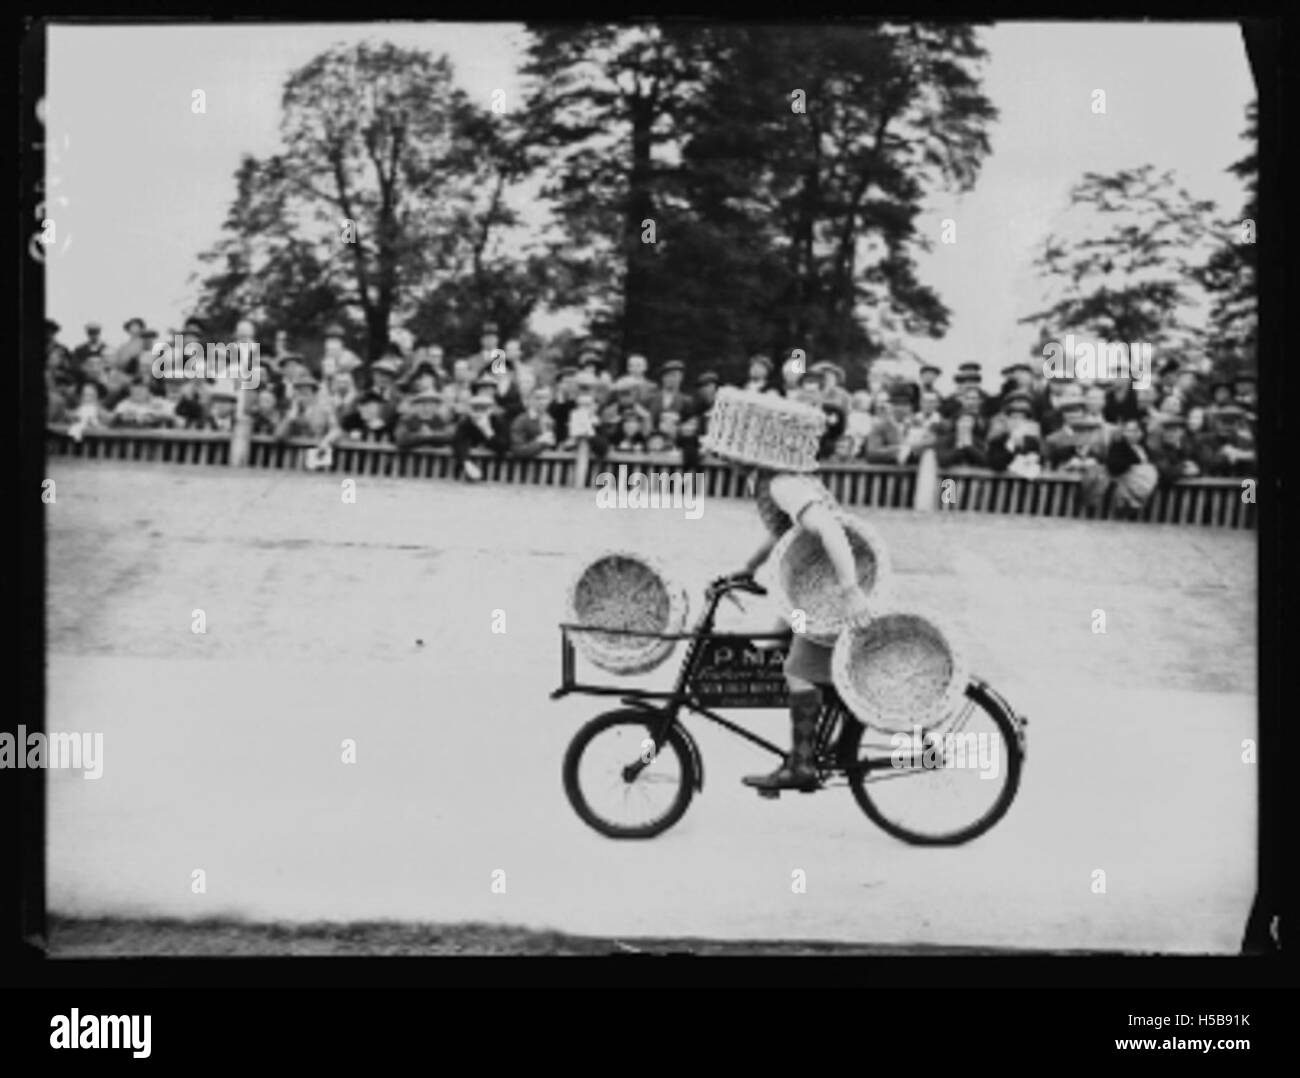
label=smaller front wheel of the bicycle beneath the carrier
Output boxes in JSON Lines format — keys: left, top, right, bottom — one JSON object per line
{"left": 564, "top": 710, "right": 696, "bottom": 839}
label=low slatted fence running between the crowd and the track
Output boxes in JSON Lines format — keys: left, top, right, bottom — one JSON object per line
{"left": 47, "top": 425, "right": 1256, "bottom": 528}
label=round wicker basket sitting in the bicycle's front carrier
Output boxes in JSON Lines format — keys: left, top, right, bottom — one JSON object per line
{"left": 568, "top": 551, "right": 688, "bottom": 674}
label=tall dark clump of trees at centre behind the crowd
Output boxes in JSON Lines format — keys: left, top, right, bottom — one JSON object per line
{"left": 517, "top": 23, "right": 995, "bottom": 382}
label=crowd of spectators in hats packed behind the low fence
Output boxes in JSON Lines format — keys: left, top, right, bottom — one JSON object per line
{"left": 46, "top": 309, "right": 1256, "bottom": 499}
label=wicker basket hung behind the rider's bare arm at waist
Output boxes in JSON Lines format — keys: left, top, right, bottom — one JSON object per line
{"left": 771, "top": 508, "right": 889, "bottom": 646}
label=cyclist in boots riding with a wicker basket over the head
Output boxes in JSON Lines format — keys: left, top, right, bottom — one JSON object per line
{"left": 703, "top": 386, "right": 871, "bottom": 792}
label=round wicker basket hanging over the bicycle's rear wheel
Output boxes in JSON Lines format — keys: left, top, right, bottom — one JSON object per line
{"left": 831, "top": 610, "right": 967, "bottom": 732}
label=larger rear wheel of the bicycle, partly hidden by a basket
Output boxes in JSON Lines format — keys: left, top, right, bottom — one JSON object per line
{"left": 841, "top": 681, "right": 1024, "bottom": 845}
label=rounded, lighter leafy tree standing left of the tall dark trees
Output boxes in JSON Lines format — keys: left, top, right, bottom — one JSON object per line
{"left": 192, "top": 44, "right": 520, "bottom": 359}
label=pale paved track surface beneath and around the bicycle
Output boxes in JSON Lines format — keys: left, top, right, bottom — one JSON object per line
{"left": 47, "top": 462, "right": 1256, "bottom": 952}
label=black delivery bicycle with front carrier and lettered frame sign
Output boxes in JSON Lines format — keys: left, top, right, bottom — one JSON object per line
{"left": 550, "top": 576, "right": 1028, "bottom": 845}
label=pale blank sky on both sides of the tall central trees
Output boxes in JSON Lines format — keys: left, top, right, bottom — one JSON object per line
{"left": 46, "top": 21, "right": 1255, "bottom": 371}
